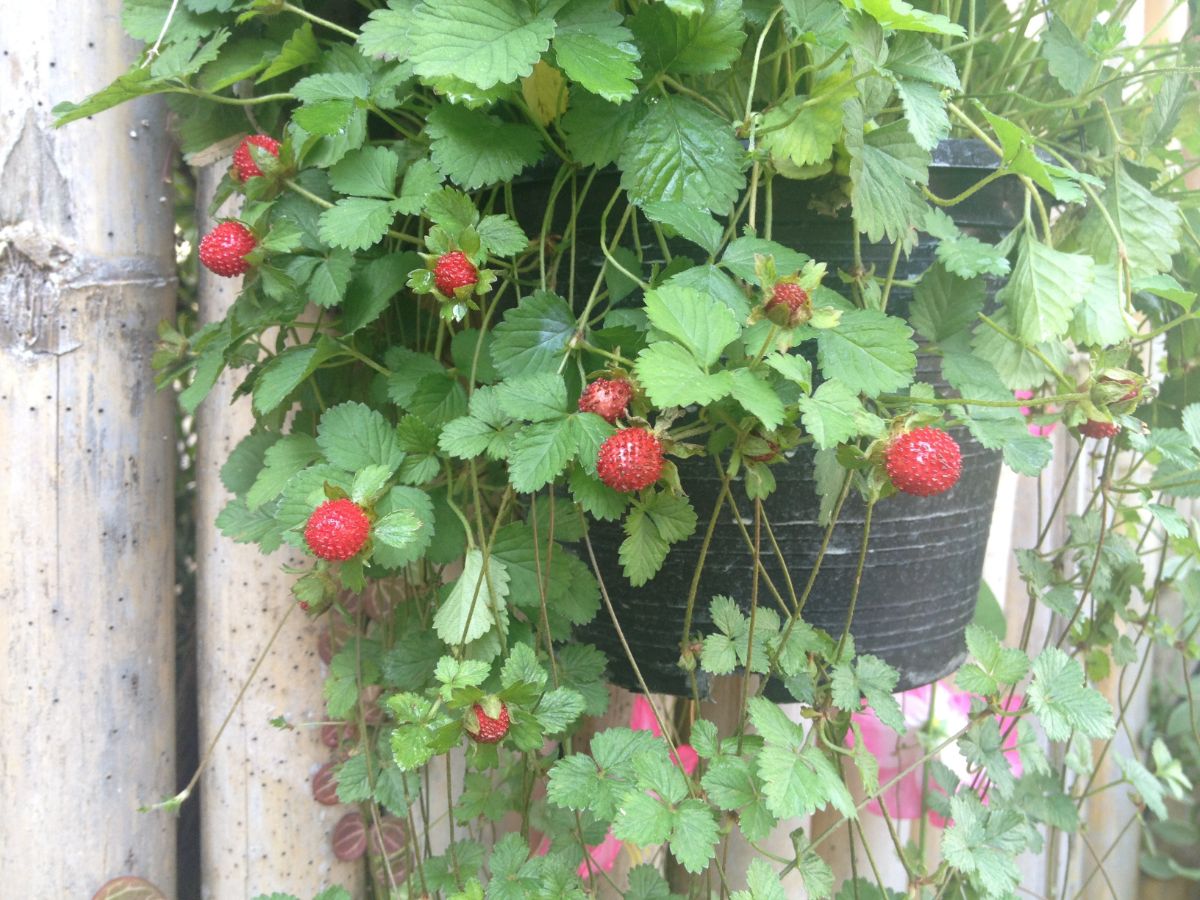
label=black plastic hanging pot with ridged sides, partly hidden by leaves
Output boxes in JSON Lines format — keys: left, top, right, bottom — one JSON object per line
{"left": 566, "top": 140, "right": 1024, "bottom": 696}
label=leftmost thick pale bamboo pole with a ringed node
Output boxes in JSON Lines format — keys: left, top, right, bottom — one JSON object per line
{"left": 0, "top": 0, "right": 176, "bottom": 898}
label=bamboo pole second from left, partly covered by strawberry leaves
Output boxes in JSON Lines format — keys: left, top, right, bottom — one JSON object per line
{"left": 196, "top": 167, "right": 364, "bottom": 900}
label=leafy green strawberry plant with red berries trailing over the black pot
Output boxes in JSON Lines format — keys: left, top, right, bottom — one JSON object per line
{"left": 58, "top": 0, "right": 1200, "bottom": 900}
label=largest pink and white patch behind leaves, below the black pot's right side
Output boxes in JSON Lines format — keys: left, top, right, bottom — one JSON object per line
{"left": 846, "top": 679, "right": 1022, "bottom": 828}
